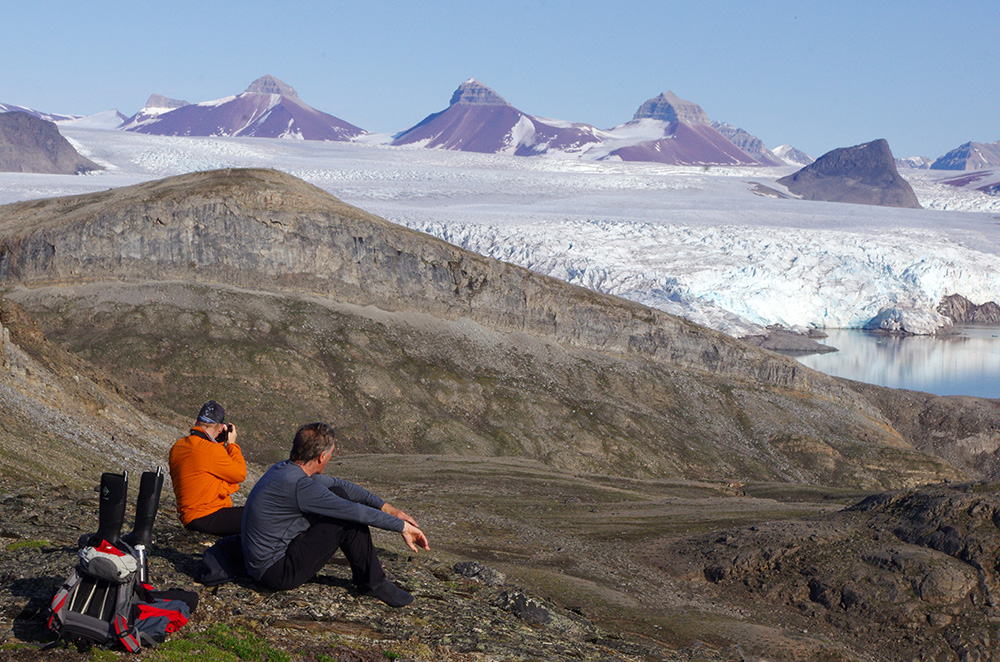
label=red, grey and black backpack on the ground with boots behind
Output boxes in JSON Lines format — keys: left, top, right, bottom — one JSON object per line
{"left": 48, "top": 540, "right": 198, "bottom": 653}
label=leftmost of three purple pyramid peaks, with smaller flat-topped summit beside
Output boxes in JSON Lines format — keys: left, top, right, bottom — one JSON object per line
{"left": 121, "top": 76, "right": 366, "bottom": 141}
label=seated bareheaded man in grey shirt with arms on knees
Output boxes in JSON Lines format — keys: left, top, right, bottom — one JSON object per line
{"left": 242, "top": 423, "right": 430, "bottom": 607}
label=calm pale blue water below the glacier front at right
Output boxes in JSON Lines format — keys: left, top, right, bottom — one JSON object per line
{"left": 798, "top": 326, "right": 1000, "bottom": 398}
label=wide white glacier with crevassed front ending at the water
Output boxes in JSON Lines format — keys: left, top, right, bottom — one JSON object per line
{"left": 0, "top": 123, "right": 1000, "bottom": 336}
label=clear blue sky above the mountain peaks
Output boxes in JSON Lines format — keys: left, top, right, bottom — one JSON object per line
{"left": 0, "top": 0, "right": 1000, "bottom": 158}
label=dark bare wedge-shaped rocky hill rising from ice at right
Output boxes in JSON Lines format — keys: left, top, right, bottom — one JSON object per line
{"left": 778, "top": 140, "right": 920, "bottom": 209}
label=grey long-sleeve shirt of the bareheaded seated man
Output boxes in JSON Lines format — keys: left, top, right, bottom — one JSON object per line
{"left": 242, "top": 460, "right": 404, "bottom": 579}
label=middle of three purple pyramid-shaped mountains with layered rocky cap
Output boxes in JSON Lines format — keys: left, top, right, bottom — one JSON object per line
{"left": 392, "top": 78, "right": 599, "bottom": 156}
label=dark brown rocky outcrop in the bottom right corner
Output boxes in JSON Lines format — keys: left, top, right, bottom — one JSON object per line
{"left": 655, "top": 483, "right": 1000, "bottom": 661}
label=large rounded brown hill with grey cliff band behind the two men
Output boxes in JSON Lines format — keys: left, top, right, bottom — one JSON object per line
{"left": 0, "top": 170, "right": 959, "bottom": 486}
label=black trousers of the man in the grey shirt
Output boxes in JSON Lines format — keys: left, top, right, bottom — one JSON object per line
{"left": 260, "top": 487, "right": 385, "bottom": 591}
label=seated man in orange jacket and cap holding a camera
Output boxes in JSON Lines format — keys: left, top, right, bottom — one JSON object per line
{"left": 170, "top": 400, "right": 247, "bottom": 536}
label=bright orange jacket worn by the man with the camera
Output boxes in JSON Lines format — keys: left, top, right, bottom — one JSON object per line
{"left": 170, "top": 427, "right": 247, "bottom": 525}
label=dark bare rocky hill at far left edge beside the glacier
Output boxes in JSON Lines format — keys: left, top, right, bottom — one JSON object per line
{"left": 0, "top": 112, "right": 101, "bottom": 175}
